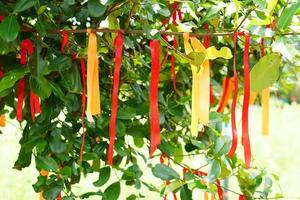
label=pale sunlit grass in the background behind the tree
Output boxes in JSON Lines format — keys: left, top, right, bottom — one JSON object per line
{"left": 0, "top": 101, "right": 300, "bottom": 200}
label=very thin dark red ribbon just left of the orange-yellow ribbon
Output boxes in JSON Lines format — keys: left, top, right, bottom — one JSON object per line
{"left": 79, "top": 58, "right": 86, "bottom": 162}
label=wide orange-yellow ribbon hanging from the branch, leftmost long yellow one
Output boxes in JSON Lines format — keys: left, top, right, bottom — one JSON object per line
{"left": 86, "top": 29, "right": 101, "bottom": 121}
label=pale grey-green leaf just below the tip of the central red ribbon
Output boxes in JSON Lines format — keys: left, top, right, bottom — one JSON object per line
{"left": 152, "top": 164, "right": 180, "bottom": 181}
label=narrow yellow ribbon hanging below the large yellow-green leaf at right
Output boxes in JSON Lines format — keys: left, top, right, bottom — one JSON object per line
{"left": 261, "top": 87, "right": 270, "bottom": 136}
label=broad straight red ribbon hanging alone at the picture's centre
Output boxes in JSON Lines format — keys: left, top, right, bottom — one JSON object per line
{"left": 150, "top": 40, "right": 160, "bottom": 156}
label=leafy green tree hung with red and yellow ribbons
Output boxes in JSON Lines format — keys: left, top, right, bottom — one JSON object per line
{"left": 0, "top": 0, "right": 299, "bottom": 200}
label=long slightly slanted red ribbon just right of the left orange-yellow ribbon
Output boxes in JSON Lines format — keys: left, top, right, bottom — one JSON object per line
{"left": 107, "top": 31, "right": 124, "bottom": 165}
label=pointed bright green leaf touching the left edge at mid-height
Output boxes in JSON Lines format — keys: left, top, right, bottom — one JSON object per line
{"left": 0, "top": 68, "right": 28, "bottom": 93}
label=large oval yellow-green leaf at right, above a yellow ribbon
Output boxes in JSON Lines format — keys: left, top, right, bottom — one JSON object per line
{"left": 250, "top": 53, "right": 281, "bottom": 92}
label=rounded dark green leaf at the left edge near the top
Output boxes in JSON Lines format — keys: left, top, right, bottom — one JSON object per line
{"left": 0, "top": 15, "right": 20, "bottom": 42}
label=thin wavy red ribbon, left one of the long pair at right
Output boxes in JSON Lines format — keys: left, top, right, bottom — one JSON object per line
{"left": 228, "top": 33, "right": 239, "bottom": 157}
